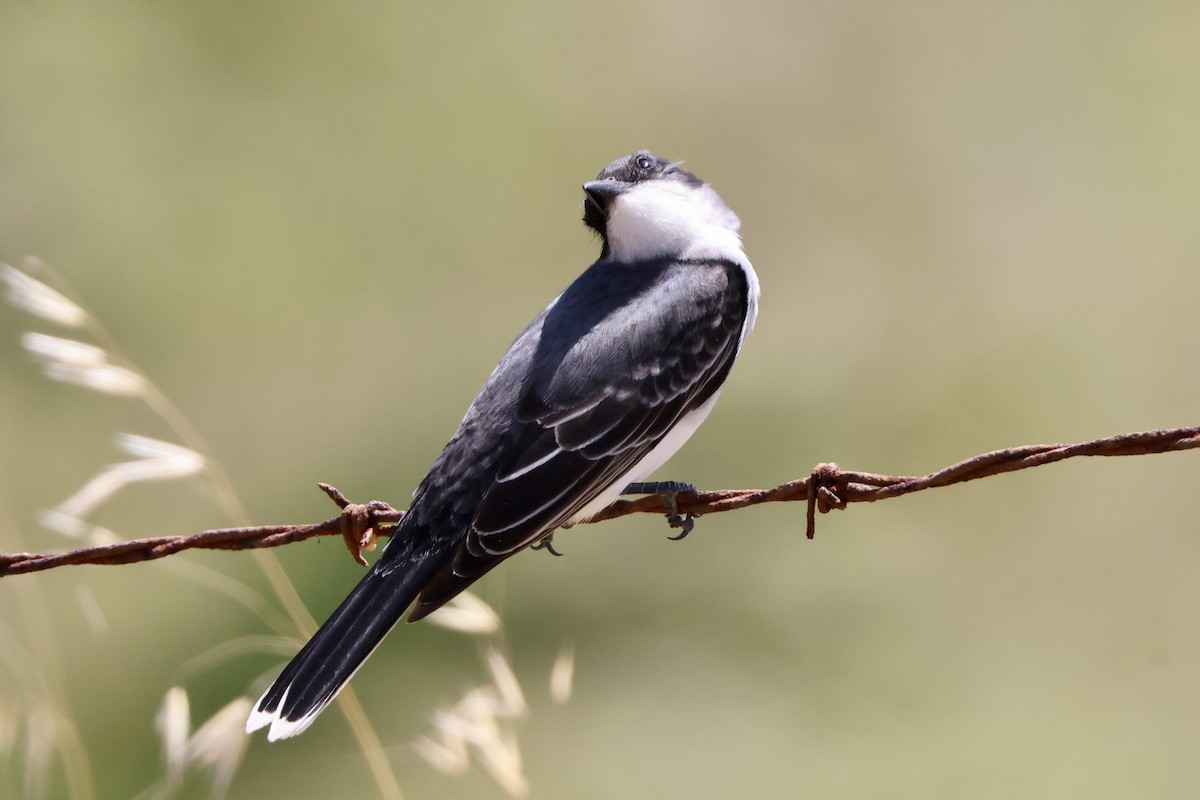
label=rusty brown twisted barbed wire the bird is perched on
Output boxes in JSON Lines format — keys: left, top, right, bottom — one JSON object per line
{"left": 0, "top": 427, "right": 1200, "bottom": 577}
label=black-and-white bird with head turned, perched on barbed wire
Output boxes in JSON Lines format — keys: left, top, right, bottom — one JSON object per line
{"left": 246, "top": 150, "right": 760, "bottom": 741}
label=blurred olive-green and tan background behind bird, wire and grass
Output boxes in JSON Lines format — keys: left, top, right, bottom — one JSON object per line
{"left": 0, "top": 0, "right": 1200, "bottom": 798}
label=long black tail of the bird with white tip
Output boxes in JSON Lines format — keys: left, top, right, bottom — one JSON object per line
{"left": 246, "top": 541, "right": 449, "bottom": 741}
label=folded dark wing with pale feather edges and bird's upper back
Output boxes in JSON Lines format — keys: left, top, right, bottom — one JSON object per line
{"left": 409, "top": 261, "right": 748, "bottom": 620}
